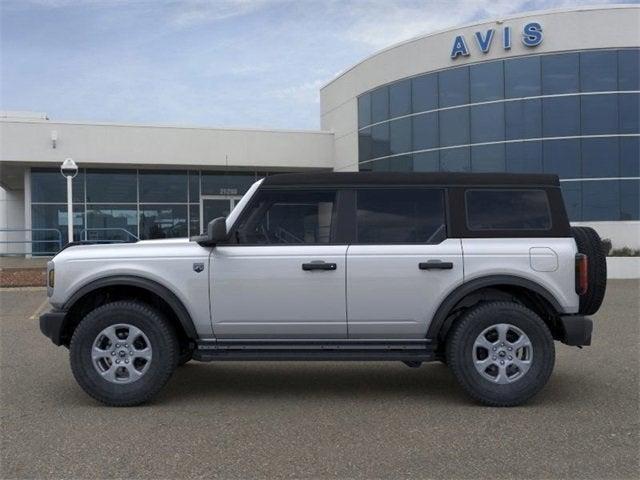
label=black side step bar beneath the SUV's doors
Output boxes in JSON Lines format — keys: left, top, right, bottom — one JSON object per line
{"left": 193, "top": 340, "right": 436, "bottom": 362}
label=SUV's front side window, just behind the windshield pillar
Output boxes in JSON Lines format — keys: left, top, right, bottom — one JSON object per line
{"left": 235, "top": 190, "right": 336, "bottom": 245}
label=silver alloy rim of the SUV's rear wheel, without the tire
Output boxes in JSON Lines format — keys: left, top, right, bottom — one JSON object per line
{"left": 472, "top": 323, "right": 533, "bottom": 384}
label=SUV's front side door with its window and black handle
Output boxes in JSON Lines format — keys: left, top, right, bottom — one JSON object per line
{"left": 210, "top": 190, "right": 347, "bottom": 338}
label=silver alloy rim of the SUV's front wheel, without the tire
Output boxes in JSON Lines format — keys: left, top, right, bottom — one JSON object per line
{"left": 91, "top": 323, "right": 152, "bottom": 384}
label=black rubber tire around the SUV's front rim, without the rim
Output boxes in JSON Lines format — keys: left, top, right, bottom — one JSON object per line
{"left": 69, "top": 301, "right": 179, "bottom": 407}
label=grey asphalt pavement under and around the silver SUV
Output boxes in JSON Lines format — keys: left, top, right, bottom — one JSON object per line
{"left": 0, "top": 281, "right": 640, "bottom": 479}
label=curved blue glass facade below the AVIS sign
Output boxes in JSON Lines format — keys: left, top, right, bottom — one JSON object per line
{"left": 358, "top": 49, "right": 640, "bottom": 221}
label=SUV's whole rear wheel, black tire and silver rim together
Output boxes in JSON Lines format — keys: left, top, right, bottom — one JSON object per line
{"left": 446, "top": 302, "right": 555, "bottom": 407}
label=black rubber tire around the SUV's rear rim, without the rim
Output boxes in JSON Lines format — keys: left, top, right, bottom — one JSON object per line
{"left": 446, "top": 302, "right": 555, "bottom": 407}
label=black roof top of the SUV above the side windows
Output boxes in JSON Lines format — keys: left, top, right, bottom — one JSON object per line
{"left": 262, "top": 172, "right": 560, "bottom": 187}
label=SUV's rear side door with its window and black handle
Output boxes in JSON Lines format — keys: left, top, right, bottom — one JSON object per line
{"left": 347, "top": 187, "right": 463, "bottom": 338}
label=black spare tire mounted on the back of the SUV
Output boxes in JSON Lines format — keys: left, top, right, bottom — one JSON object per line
{"left": 571, "top": 227, "right": 607, "bottom": 315}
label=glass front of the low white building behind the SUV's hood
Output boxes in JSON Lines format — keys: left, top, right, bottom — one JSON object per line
{"left": 31, "top": 168, "right": 280, "bottom": 254}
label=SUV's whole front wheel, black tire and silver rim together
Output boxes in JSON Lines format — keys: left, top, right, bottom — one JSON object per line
{"left": 70, "top": 301, "right": 178, "bottom": 406}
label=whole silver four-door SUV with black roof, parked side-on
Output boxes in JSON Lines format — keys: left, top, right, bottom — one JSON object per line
{"left": 40, "top": 172, "right": 606, "bottom": 406}
